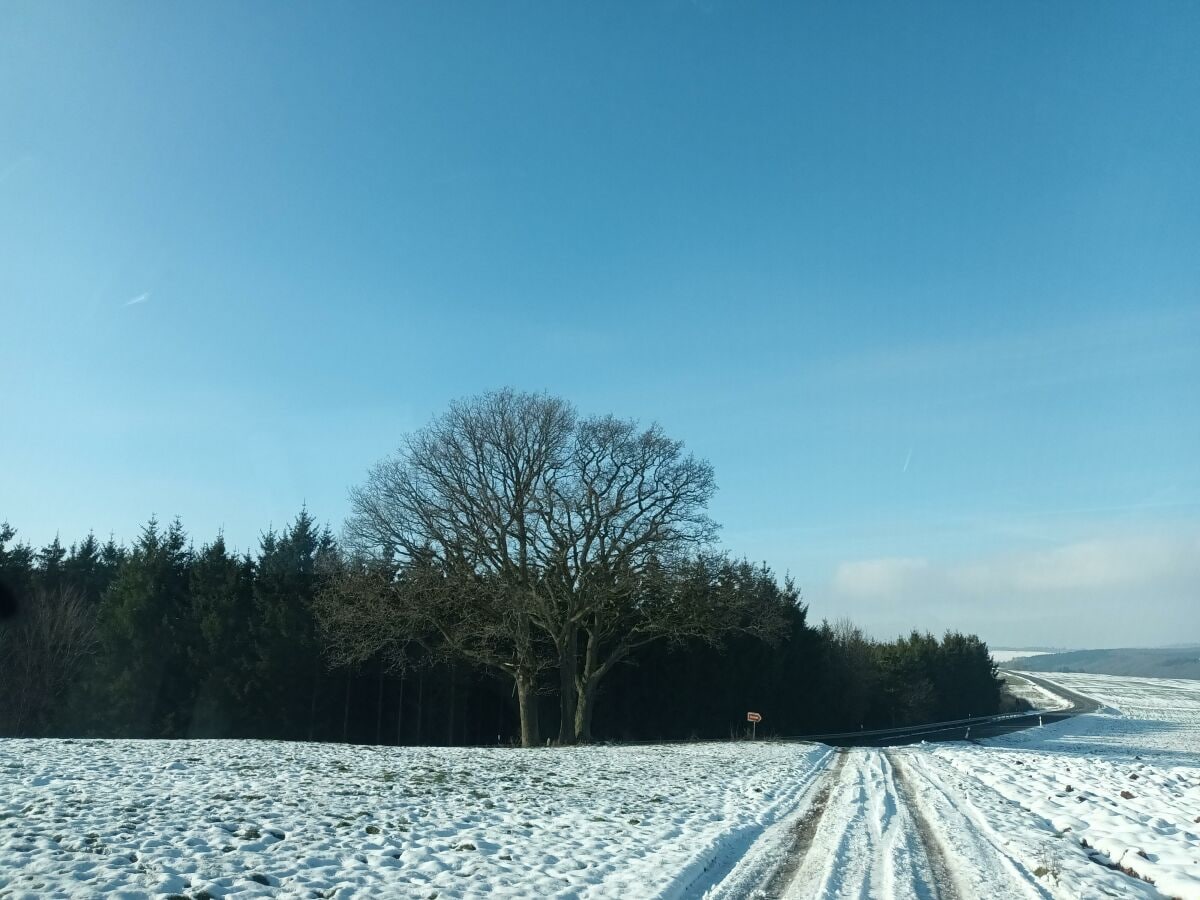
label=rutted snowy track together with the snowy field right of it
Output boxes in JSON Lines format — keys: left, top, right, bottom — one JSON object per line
{"left": 710, "top": 676, "right": 1200, "bottom": 900}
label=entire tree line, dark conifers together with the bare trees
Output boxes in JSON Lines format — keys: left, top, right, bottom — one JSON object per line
{"left": 0, "top": 391, "right": 1000, "bottom": 745}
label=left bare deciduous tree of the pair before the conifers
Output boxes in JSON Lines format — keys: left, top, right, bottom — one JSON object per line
{"left": 346, "top": 391, "right": 575, "bottom": 746}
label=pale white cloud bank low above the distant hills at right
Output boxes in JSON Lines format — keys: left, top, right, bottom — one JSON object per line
{"left": 814, "top": 533, "right": 1200, "bottom": 647}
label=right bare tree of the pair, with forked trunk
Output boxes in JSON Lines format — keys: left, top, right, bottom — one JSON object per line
{"left": 536, "top": 416, "right": 716, "bottom": 744}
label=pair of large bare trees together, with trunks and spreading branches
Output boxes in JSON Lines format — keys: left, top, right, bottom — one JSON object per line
{"left": 336, "top": 390, "right": 787, "bottom": 745}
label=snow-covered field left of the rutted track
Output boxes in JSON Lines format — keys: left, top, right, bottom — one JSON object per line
{"left": 0, "top": 740, "right": 830, "bottom": 900}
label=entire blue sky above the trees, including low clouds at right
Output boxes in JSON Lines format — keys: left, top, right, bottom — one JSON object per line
{"left": 0, "top": 0, "right": 1200, "bottom": 646}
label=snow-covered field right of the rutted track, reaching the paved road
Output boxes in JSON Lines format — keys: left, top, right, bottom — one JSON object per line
{"left": 906, "top": 673, "right": 1200, "bottom": 898}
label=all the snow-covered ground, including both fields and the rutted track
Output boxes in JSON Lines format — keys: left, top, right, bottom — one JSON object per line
{"left": 0, "top": 674, "right": 1200, "bottom": 900}
